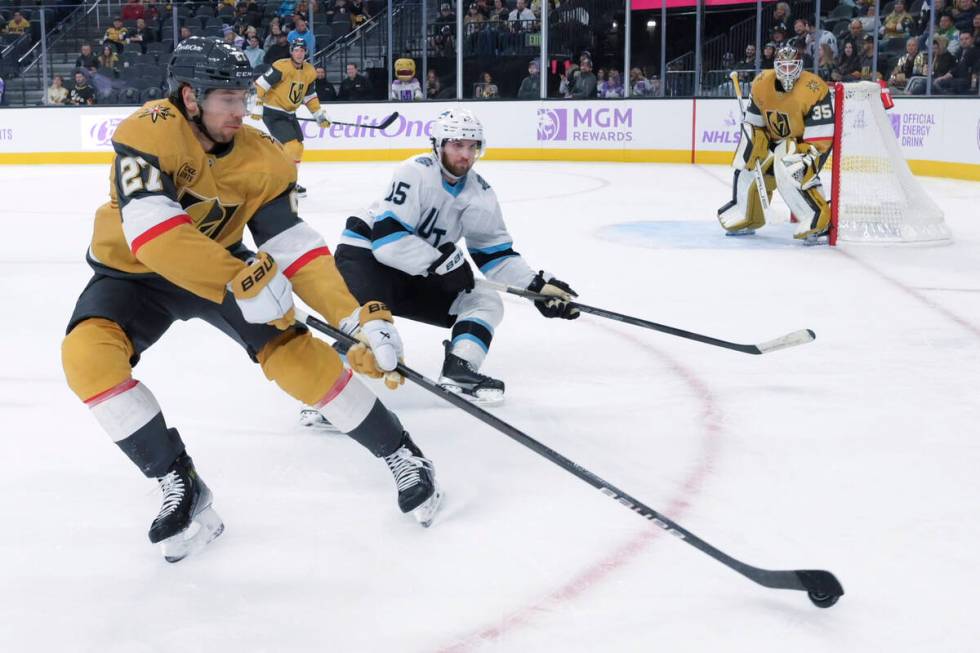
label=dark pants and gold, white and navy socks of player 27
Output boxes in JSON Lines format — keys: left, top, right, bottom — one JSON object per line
{"left": 61, "top": 274, "right": 403, "bottom": 478}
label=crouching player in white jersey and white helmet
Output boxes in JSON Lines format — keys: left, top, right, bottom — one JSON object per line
{"left": 322, "top": 109, "right": 579, "bottom": 404}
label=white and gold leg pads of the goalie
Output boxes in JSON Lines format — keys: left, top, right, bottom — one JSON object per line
{"left": 718, "top": 139, "right": 830, "bottom": 238}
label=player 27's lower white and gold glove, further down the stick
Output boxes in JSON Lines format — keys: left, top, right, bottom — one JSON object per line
{"left": 340, "top": 301, "right": 405, "bottom": 390}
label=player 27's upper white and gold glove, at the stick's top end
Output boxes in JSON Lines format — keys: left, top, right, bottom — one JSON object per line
{"left": 228, "top": 252, "right": 294, "bottom": 330}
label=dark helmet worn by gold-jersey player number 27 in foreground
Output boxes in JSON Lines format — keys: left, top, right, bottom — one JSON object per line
{"left": 167, "top": 36, "right": 252, "bottom": 98}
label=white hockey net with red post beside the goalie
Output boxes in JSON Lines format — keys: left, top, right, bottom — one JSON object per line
{"left": 830, "top": 82, "right": 950, "bottom": 245}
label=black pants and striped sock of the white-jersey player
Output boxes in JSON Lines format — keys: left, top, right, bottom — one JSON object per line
{"left": 335, "top": 245, "right": 504, "bottom": 369}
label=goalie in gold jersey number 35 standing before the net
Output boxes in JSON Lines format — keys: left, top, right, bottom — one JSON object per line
{"left": 718, "top": 46, "right": 834, "bottom": 243}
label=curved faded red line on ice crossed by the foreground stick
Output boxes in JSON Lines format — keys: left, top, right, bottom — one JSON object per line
{"left": 437, "top": 330, "right": 722, "bottom": 653}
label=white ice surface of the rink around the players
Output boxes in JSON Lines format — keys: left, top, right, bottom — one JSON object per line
{"left": 0, "top": 162, "right": 980, "bottom": 653}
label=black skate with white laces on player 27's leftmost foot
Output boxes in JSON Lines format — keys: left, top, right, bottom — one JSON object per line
{"left": 149, "top": 453, "right": 225, "bottom": 562}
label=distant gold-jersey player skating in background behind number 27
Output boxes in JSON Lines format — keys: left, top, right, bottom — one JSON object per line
{"left": 252, "top": 38, "right": 330, "bottom": 197}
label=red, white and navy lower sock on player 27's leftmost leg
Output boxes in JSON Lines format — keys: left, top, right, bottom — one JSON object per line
{"left": 85, "top": 379, "right": 184, "bottom": 478}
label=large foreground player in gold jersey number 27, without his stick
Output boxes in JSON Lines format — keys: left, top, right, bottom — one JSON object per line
{"left": 62, "top": 37, "right": 440, "bottom": 562}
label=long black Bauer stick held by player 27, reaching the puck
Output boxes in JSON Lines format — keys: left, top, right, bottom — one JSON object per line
{"left": 296, "top": 310, "right": 844, "bottom": 608}
